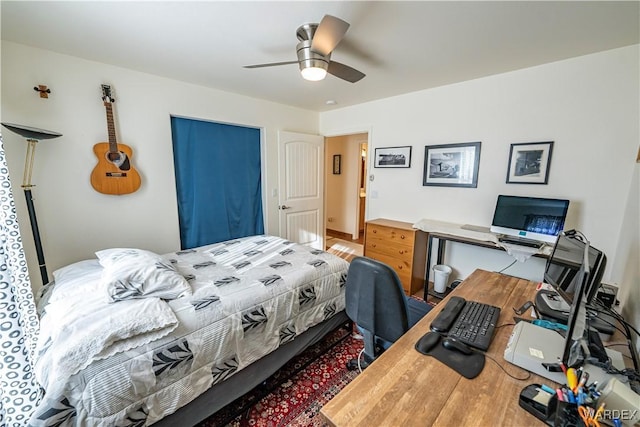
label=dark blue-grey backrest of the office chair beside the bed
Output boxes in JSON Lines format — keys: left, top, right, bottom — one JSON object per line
{"left": 345, "top": 257, "right": 409, "bottom": 342}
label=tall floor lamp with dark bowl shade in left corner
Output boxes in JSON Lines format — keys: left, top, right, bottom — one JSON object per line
{"left": 2, "top": 123, "right": 62, "bottom": 285}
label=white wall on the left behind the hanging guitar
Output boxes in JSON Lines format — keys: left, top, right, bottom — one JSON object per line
{"left": 1, "top": 41, "right": 318, "bottom": 288}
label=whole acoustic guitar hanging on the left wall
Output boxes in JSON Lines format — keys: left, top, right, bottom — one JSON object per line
{"left": 91, "top": 85, "right": 141, "bottom": 195}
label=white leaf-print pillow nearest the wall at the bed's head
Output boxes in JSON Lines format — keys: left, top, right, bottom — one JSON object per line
{"left": 96, "top": 248, "right": 191, "bottom": 302}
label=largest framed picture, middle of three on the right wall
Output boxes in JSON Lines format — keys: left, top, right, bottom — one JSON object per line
{"left": 422, "top": 142, "right": 480, "bottom": 188}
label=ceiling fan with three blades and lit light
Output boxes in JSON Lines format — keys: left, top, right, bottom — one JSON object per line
{"left": 244, "top": 15, "right": 365, "bottom": 83}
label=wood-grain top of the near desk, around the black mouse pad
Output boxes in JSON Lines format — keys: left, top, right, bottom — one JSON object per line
{"left": 321, "top": 270, "right": 554, "bottom": 426}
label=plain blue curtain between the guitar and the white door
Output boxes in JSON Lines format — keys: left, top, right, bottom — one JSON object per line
{"left": 171, "top": 117, "right": 264, "bottom": 249}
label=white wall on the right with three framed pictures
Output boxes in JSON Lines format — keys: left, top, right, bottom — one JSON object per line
{"left": 320, "top": 45, "right": 640, "bottom": 294}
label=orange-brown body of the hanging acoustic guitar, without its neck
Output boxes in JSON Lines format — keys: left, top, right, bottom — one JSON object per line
{"left": 91, "top": 142, "right": 142, "bottom": 195}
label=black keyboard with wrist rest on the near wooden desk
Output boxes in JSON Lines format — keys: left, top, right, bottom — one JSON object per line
{"left": 431, "top": 296, "right": 500, "bottom": 351}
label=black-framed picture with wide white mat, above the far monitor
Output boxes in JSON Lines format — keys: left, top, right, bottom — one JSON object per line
{"left": 507, "top": 141, "right": 553, "bottom": 184}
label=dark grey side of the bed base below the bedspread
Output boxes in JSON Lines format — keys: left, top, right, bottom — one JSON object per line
{"left": 153, "top": 311, "right": 350, "bottom": 427}
